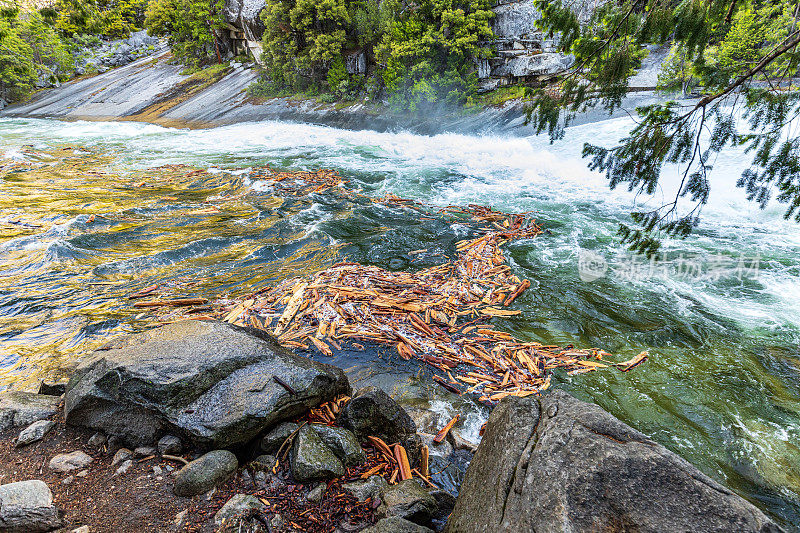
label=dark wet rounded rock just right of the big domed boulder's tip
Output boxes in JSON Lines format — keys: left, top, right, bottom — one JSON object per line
{"left": 339, "top": 387, "right": 417, "bottom": 443}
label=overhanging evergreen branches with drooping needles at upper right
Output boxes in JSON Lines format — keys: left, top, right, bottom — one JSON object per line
{"left": 528, "top": 0, "right": 800, "bottom": 256}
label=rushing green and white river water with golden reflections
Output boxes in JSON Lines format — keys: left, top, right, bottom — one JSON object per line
{"left": 0, "top": 114, "right": 800, "bottom": 528}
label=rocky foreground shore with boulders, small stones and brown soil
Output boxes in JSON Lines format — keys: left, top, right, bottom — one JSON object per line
{"left": 0, "top": 321, "right": 781, "bottom": 533}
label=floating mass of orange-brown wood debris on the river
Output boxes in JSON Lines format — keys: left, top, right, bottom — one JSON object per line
{"left": 134, "top": 170, "right": 646, "bottom": 402}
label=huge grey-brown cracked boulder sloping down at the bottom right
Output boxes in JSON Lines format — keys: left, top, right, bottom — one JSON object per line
{"left": 446, "top": 391, "right": 780, "bottom": 533}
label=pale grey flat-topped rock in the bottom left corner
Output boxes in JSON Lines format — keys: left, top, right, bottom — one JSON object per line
{"left": 0, "top": 479, "right": 62, "bottom": 533}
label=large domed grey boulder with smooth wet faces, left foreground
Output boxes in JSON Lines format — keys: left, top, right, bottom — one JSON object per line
{"left": 65, "top": 320, "right": 350, "bottom": 448}
